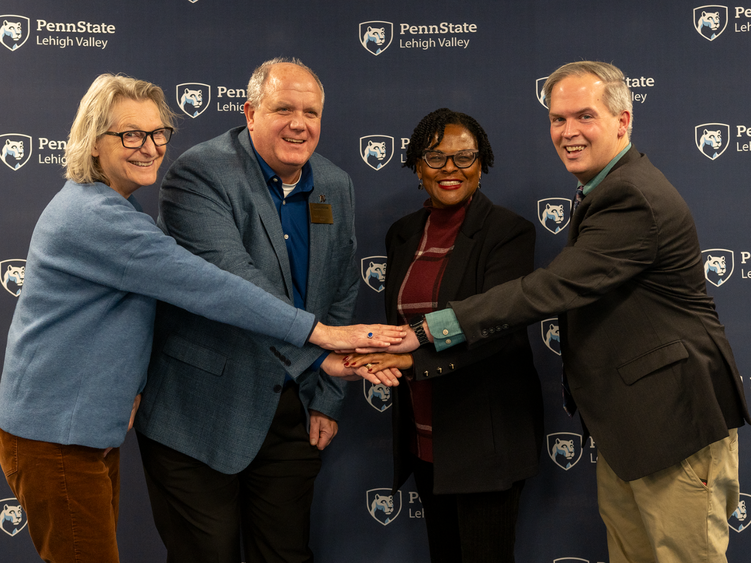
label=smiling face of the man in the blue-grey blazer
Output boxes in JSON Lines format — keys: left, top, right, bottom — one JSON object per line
{"left": 243, "top": 63, "right": 323, "bottom": 183}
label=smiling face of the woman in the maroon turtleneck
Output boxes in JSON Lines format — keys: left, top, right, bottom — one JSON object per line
{"left": 415, "top": 123, "right": 482, "bottom": 208}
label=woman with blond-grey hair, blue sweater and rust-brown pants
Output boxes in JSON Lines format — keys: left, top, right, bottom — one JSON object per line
{"left": 0, "top": 74, "right": 401, "bottom": 563}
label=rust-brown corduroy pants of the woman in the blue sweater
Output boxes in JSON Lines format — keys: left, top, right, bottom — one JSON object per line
{"left": 0, "top": 430, "right": 120, "bottom": 563}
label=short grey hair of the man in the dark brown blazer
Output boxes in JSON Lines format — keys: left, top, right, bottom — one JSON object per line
{"left": 542, "top": 61, "right": 634, "bottom": 138}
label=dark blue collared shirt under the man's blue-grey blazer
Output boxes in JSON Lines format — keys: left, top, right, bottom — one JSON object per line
{"left": 248, "top": 131, "right": 329, "bottom": 377}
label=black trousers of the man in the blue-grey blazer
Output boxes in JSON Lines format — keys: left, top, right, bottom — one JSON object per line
{"left": 138, "top": 385, "right": 321, "bottom": 563}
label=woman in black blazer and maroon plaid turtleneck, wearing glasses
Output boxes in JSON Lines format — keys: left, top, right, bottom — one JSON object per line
{"left": 346, "top": 108, "right": 543, "bottom": 563}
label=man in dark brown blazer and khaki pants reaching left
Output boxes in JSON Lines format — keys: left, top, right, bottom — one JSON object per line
{"left": 381, "top": 61, "right": 749, "bottom": 563}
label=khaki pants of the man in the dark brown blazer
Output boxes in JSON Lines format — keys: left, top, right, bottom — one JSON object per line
{"left": 597, "top": 429, "right": 740, "bottom": 563}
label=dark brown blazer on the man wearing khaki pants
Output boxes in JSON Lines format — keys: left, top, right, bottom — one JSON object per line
{"left": 450, "top": 147, "right": 749, "bottom": 481}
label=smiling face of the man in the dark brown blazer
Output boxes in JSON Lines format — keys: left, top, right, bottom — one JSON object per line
{"left": 549, "top": 74, "right": 631, "bottom": 184}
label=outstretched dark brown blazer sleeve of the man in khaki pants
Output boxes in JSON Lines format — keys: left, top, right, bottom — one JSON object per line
{"left": 449, "top": 177, "right": 659, "bottom": 347}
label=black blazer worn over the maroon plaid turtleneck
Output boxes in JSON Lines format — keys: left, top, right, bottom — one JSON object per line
{"left": 385, "top": 191, "right": 543, "bottom": 494}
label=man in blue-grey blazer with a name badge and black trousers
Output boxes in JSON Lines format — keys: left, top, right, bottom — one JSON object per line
{"left": 136, "top": 59, "right": 359, "bottom": 563}
